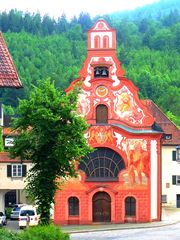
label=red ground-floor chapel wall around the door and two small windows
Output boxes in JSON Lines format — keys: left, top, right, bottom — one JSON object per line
{"left": 54, "top": 180, "right": 151, "bottom": 225}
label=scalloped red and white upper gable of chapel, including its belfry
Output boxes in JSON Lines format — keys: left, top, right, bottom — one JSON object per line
{"left": 67, "top": 20, "right": 154, "bottom": 129}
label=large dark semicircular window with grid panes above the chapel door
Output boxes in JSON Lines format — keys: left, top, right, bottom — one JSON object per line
{"left": 79, "top": 148, "right": 125, "bottom": 182}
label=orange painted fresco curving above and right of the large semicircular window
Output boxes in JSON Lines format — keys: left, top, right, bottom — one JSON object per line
{"left": 85, "top": 126, "right": 150, "bottom": 186}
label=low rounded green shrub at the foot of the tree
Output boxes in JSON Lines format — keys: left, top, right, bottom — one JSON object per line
{"left": 19, "top": 225, "right": 70, "bottom": 240}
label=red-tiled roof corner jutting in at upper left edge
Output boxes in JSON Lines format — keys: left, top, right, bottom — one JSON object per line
{"left": 0, "top": 32, "right": 22, "bottom": 88}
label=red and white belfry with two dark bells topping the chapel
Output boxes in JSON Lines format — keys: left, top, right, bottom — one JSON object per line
{"left": 79, "top": 19, "right": 124, "bottom": 88}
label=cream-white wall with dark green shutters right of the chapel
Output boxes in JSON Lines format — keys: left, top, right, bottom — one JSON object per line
{"left": 162, "top": 146, "right": 180, "bottom": 207}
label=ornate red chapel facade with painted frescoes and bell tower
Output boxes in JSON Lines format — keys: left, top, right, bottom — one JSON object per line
{"left": 54, "top": 20, "right": 162, "bottom": 224}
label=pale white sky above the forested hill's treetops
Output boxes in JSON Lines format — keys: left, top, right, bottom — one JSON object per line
{"left": 0, "top": 0, "right": 159, "bottom": 19}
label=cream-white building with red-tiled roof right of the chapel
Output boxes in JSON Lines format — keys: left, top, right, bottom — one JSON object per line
{"left": 144, "top": 100, "right": 180, "bottom": 208}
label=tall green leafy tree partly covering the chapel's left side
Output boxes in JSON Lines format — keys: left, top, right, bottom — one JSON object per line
{"left": 10, "top": 79, "right": 91, "bottom": 224}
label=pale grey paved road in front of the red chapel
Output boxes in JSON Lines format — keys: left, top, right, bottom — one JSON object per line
{"left": 71, "top": 223, "right": 180, "bottom": 240}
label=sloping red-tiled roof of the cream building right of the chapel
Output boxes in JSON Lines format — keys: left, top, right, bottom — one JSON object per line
{"left": 142, "top": 99, "right": 180, "bottom": 145}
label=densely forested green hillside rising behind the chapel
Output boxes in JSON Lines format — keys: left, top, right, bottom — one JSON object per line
{"left": 0, "top": 0, "right": 180, "bottom": 125}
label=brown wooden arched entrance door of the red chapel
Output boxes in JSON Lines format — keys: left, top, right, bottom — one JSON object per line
{"left": 93, "top": 192, "right": 111, "bottom": 222}
